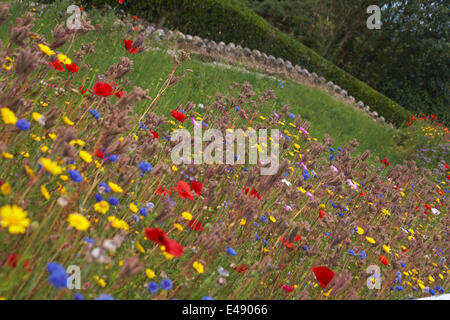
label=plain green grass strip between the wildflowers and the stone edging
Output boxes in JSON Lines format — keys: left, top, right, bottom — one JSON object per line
{"left": 0, "top": 2, "right": 403, "bottom": 164}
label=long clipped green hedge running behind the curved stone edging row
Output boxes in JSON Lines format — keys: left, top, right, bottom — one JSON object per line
{"left": 85, "top": 0, "right": 410, "bottom": 126}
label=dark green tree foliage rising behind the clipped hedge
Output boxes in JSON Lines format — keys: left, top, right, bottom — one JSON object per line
{"left": 245, "top": 0, "right": 450, "bottom": 124}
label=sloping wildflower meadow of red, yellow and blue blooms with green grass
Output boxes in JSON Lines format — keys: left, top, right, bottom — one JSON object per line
{"left": 0, "top": 1, "right": 450, "bottom": 300}
